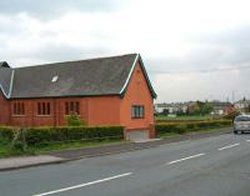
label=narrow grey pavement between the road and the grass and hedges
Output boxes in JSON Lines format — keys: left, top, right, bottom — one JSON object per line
{"left": 0, "top": 129, "right": 232, "bottom": 171}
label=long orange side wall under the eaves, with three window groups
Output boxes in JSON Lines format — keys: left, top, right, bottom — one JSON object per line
{"left": 0, "top": 96, "right": 121, "bottom": 126}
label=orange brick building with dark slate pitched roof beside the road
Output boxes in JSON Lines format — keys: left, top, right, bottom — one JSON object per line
{"left": 0, "top": 54, "right": 156, "bottom": 137}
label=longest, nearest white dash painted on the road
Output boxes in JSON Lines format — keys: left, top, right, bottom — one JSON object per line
{"left": 33, "top": 172, "right": 133, "bottom": 196}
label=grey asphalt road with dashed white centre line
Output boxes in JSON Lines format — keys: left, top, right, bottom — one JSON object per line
{"left": 0, "top": 130, "right": 250, "bottom": 196}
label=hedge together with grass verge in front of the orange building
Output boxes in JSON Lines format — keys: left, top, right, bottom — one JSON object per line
{"left": 0, "top": 126, "right": 124, "bottom": 157}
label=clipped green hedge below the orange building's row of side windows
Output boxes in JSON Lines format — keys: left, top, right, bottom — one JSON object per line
{"left": 0, "top": 126, "right": 124, "bottom": 145}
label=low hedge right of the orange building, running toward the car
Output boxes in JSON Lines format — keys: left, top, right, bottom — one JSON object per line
{"left": 155, "top": 120, "right": 232, "bottom": 136}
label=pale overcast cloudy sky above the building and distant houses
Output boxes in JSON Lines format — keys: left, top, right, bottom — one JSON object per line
{"left": 0, "top": 0, "right": 250, "bottom": 103}
